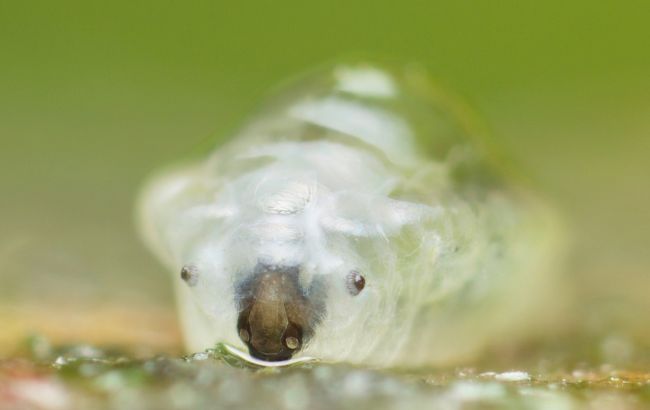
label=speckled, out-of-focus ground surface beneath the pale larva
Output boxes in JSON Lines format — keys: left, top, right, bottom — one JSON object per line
{"left": 0, "top": 336, "right": 650, "bottom": 410}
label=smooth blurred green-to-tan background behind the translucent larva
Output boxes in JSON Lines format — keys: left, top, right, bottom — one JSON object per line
{"left": 0, "top": 0, "right": 650, "bottom": 347}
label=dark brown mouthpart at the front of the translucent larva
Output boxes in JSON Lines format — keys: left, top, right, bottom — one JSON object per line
{"left": 236, "top": 264, "right": 324, "bottom": 361}
